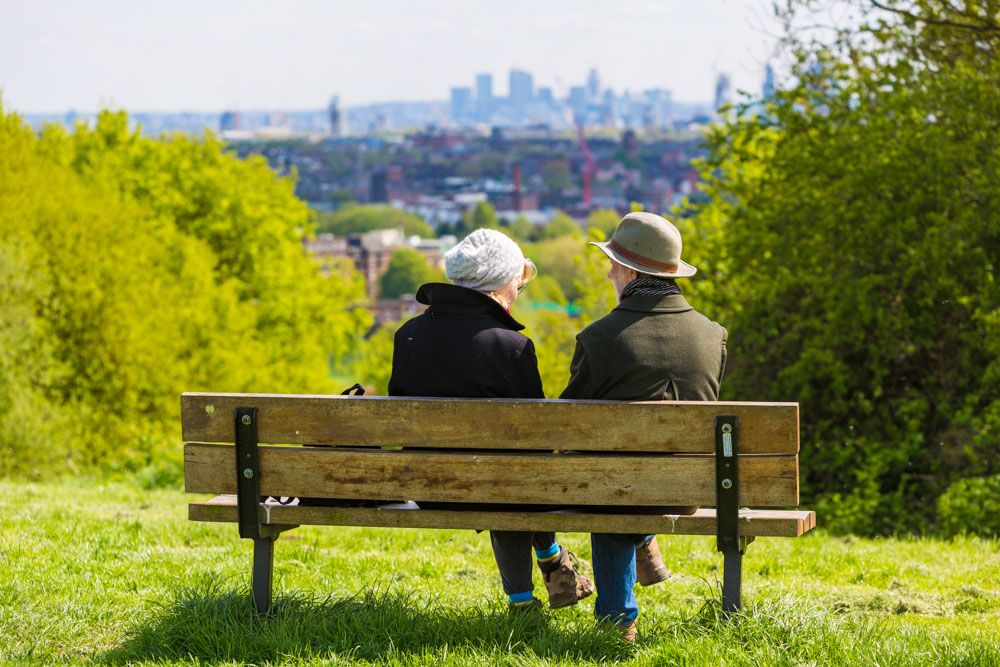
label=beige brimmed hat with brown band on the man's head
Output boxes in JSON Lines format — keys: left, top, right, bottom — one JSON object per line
{"left": 590, "top": 212, "right": 698, "bottom": 278}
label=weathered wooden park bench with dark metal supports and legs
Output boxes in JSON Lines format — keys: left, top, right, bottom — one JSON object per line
{"left": 181, "top": 393, "right": 816, "bottom": 612}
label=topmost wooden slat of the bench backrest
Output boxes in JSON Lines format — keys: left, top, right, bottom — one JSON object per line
{"left": 181, "top": 393, "right": 799, "bottom": 454}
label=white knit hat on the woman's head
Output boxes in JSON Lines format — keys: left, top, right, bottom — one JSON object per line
{"left": 444, "top": 229, "right": 524, "bottom": 292}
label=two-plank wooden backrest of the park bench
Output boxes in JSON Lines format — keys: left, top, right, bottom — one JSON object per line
{"left": 181, "top": 393, "right": 799, "bottom": 507}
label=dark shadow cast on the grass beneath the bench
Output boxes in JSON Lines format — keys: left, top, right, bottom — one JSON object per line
{"left": 101, "top": 581, "right": 632, "bottom": 665}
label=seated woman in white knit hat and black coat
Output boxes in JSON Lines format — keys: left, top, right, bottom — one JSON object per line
{"left": 389, "top": 229, "right": 594, "bottom": 608}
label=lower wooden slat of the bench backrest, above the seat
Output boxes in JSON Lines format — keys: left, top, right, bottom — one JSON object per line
{"left": 184, "top": 443, "right": 799, "bottom": 507}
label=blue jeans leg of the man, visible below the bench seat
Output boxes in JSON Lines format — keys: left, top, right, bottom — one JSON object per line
{"left": 590, "top": 533, "right": 652, "bottom": 625}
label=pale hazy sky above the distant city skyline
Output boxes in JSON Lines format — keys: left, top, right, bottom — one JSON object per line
{"left": 0, "top": 0, "right": 788, "bottom": 113}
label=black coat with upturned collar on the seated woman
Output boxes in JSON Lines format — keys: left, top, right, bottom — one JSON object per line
{"left": 389, "top": 283, "right": 544, "bottom": 398}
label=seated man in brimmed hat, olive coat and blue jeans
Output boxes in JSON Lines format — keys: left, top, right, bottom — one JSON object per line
{"left": 561, "top": 213, "right": 727, "bottom": 641}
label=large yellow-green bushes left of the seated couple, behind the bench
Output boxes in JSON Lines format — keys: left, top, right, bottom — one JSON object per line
{"left": 0, "top": 109, "right": 370, "bottom": 476}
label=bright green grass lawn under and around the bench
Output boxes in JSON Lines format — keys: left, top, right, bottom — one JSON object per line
{"left": 0, "top": 481, "right": 1000, "bottom": 665}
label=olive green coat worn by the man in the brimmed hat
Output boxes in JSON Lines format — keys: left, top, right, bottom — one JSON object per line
{"left": 561, "top": 294, "right": 728, "bottom": 401}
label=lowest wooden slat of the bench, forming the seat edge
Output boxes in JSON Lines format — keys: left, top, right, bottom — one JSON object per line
{"left": 188, "top": 495, "right": 816, "bottom": 537}
